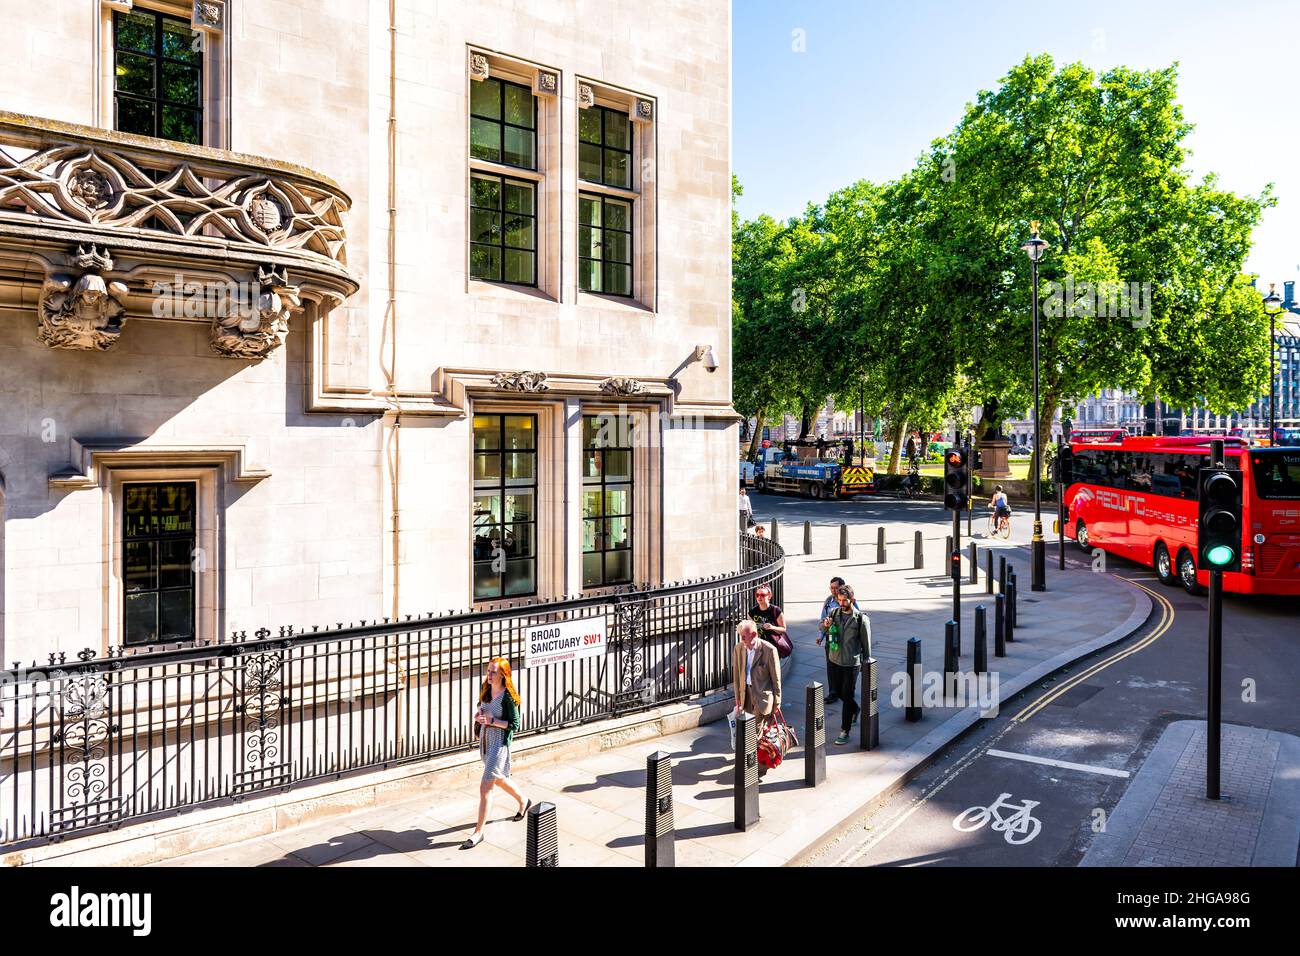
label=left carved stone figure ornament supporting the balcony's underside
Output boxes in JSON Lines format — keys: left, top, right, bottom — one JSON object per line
{"left": 36, "top": 243, "right": 127, "bottom": 351}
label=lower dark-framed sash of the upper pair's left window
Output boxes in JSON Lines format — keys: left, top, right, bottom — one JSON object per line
{"left": 469, "top": 173, "right": 537, "bottom": 286}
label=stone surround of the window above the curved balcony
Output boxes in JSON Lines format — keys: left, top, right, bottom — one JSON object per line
{"left": 95, "top": 0, "right": 230, "bottom": 150}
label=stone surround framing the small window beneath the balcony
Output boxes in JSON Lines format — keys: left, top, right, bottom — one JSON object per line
{"left": 99, "top": 463, "right": 222, "bottom": 654}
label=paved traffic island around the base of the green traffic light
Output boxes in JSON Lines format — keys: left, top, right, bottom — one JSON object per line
{"left": 1079, "top": 721, "right": 1300, "bottom": 866}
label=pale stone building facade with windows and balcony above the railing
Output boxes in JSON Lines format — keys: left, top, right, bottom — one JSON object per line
{"left": 0, "top": 0, "right": 738, "bottom": 666}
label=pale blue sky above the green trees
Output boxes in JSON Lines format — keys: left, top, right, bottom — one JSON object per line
{"left": 732, "top": 0, "right": 1300, "bottom": 291}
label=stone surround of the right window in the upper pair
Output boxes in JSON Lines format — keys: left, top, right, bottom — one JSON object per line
{"left": 577, "top": 75, "right": 659, "bottom": 312}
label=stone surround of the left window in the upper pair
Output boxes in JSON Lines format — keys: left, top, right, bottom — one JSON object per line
{"left": 462, "top": 47, "right": 563, "bottom": 302}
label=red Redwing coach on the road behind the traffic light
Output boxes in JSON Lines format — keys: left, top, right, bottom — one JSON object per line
{"left": 1063, "top": 436, "right": 1300, "bottom": 594}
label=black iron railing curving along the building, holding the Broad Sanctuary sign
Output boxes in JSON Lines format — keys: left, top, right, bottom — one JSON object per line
{"left": 0, "top": 535, "right": 784, "bottom": 848}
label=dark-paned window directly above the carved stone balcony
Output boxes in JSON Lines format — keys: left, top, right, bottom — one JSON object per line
{"left": 113, "top": 8, "right": 203, "bottom": 144}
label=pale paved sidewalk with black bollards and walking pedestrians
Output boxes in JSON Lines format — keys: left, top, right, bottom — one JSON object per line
{"left": 161, "top": 523, "right": 1151, "bottom": 866}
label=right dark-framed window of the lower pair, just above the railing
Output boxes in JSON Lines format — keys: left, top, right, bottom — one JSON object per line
{"left": 582, "top": 414, "right": 634, "bottom": 588}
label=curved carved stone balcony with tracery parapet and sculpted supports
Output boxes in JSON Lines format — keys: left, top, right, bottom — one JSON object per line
{"left": 0, "top": 111, "right": 358, "bottom": 359}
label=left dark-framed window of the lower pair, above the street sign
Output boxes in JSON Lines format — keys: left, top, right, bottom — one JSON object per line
{"left": 471, "top": 414, "right": 537, "bottom": 601}
